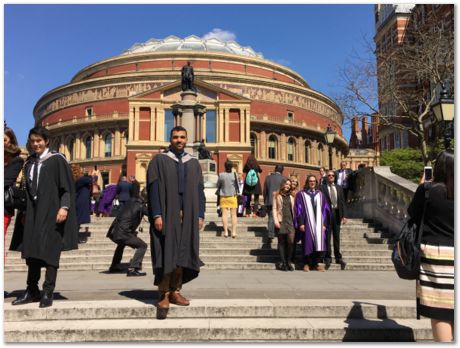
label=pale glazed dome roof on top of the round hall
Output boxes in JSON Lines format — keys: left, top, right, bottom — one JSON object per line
{"left": 121, "top": 35, "right": 264, "bottom": 59}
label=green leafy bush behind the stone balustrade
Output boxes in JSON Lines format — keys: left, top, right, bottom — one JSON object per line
{"left": 380, "top": 148, "right": 424, "bottom": 184}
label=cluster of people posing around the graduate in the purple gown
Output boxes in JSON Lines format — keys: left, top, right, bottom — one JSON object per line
{"left": 264, "top": 165, "right": 346, "bottom": 272}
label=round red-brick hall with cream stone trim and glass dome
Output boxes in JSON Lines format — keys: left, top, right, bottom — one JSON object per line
{"left": 34, "top": 36, "right": 348, "bottom": 188}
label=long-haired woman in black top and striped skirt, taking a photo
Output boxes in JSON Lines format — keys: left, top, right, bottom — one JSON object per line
{"left": 408, "top": 151, "right": 455, "bottom": 342}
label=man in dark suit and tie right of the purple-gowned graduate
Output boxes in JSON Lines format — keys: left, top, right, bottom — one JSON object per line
{"left": 320, "top": 170, "right": 347, "bottom": 270}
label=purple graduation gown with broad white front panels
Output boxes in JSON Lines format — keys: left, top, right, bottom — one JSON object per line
{"left": 294, "top": 190, "right": 331, "bottom": 256}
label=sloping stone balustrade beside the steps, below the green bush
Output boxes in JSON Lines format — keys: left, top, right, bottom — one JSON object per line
{"left": 348, "top": 167, "right": 417, "bottom": 237}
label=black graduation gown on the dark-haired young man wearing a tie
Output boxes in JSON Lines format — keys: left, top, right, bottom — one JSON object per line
{"left": 10, "top": 152, "right": 78, "bottom": 268}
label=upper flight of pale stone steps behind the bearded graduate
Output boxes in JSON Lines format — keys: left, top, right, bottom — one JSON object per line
{"left": 5, "top": 213, "right": 394, "bottom": 272}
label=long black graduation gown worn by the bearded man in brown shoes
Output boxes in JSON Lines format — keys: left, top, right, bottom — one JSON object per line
{"left": 147, "top": 151, "right": 205, "bottom": 285}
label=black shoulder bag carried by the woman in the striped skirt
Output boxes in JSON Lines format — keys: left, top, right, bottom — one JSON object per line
{"left": 391, "top": 184, "right": 430, "bottom": 280}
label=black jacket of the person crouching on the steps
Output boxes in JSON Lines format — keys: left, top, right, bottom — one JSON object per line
{"left": 107, "top": 197, "right": 148, "bottom": 243}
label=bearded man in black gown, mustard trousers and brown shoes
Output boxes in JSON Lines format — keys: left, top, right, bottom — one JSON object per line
{"left": 147, "top": 126, "right": 205, "bottom": 316}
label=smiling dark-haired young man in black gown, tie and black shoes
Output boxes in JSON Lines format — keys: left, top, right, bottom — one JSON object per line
{"left": 10, "top": 127, "right": 78, "bottom": 308}
